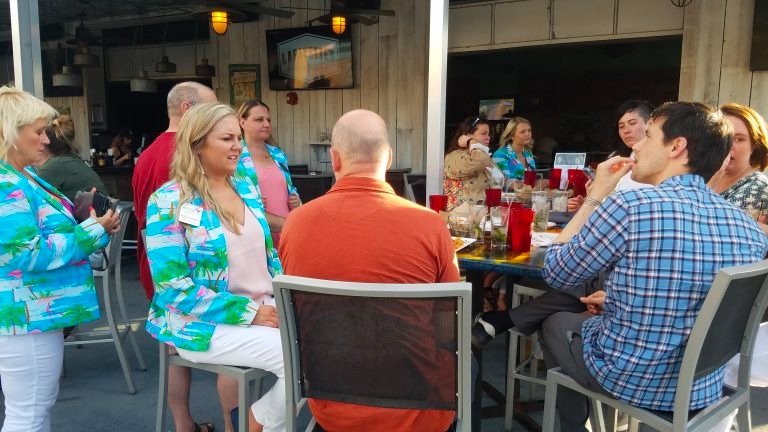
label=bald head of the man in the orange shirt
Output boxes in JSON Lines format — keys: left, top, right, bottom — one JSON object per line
{"left": 331, "top": 110, "right": 392, "bottom": 174}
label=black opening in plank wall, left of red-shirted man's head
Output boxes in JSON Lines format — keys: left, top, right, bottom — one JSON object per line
{"left": 107, "top": 78, "right": 211, "bottom": 145}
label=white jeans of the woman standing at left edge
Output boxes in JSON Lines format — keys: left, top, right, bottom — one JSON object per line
{"left": 0, "top": 330, "right": 64, "bottom": 432}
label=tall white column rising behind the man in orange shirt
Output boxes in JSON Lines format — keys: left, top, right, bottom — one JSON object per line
{"left": 426, "top": 0, "right": 448, "bottom": 196}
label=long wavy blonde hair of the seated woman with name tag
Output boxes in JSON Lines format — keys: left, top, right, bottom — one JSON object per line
{"left": 171, "top": 102, "right": 240, "bottom": 234}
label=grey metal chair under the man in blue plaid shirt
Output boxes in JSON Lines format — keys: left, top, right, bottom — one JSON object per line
{"left": 542, "top": 260, "right": 768, "bottom": 432}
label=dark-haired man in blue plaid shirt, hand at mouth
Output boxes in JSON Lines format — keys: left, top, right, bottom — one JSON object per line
{"left": 542, "top": 102, "right": 768, "bottom": 431}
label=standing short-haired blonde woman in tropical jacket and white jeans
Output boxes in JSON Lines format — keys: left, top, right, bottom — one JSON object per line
{"left": 0, "top": 87, "right": 119, "bottom": 431}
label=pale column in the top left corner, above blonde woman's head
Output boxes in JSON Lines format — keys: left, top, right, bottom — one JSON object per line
{"left": 10, "top": 0, "right": 43, "bottom": 99}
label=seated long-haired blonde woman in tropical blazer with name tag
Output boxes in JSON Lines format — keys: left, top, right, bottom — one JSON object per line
{"left": 145, "top": 103, "right": 285, "bottom": 432}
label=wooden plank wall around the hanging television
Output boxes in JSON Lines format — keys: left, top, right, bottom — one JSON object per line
{"left": 209, "top": 0, "right": 429, "bottom": 172}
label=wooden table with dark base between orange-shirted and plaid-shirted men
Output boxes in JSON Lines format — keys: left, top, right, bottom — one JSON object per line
{"left": 456, "top": 239, "right": 547, "bottom": 432}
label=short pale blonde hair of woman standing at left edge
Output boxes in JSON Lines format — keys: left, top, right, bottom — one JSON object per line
{"left": 0, "top": 86, "right": 58, "bottom": 162}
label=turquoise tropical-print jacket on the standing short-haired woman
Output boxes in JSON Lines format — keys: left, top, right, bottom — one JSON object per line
{"left": 0, "top": 161, "right": 109, "bottom": 336}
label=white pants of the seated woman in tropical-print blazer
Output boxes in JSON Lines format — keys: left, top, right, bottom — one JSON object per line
{"left": 178, "top": 324, "right": 285, "bottom": 432}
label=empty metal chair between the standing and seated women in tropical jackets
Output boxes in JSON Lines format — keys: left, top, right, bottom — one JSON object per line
{"left": 64, "top": 201, "right": 147, "bottom": 394}
